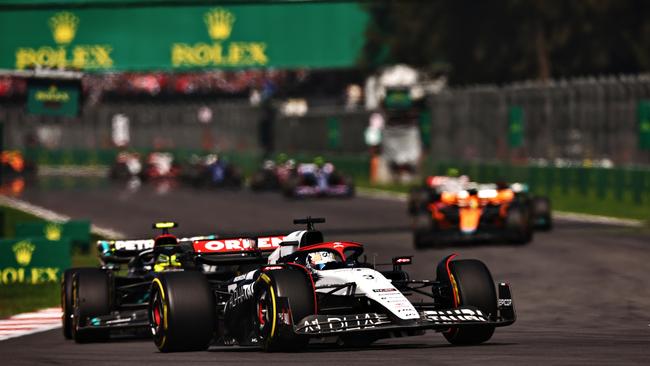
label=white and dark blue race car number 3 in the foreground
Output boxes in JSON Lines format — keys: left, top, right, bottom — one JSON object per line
{"left": 149, "top": 218, "right": 516, "bottom": 352}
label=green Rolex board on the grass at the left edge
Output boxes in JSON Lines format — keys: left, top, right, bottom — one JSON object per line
{"left": 0, "top": 238, "right": 70, "bottom": 286}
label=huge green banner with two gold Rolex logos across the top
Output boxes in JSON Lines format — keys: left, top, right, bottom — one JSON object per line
{"left": 0, "top": 2, "right": 367, "bottom": 71}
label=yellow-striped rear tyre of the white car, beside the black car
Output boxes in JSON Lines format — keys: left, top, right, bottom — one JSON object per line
{"left": 149, "top": 271, "right": 216, "bottom": 352}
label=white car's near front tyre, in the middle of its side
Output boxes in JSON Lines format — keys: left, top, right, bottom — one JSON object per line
{"left": 252, "top": 266, "right": 316, "bottom": 352}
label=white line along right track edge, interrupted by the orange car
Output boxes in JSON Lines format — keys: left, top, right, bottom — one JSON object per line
{"left": 356, "top": 188, "right": 645, "bottom": 227}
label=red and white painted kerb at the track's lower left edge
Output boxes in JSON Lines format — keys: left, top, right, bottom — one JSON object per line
{"left": 0, "top": 308, "right": 62, "bottom": 341}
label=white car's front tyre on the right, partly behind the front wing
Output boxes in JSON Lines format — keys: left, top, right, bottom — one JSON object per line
{"left": 443, "top": 259, "right": 497, "bottom": 345}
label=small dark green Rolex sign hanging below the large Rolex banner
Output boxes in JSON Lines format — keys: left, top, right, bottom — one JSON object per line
{"left": 27, "top": 80, "right": 81, "bottom": 117}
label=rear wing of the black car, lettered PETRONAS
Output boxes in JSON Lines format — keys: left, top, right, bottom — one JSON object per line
{"left": 97, "top": 235, "right": 217, "bottom": 263}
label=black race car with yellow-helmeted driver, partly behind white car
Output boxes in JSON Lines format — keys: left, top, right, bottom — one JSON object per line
{"left": 61, "top": 222, "right": 216, "bottom": 343}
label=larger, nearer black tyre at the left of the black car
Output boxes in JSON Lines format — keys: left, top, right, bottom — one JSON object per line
{"left": 72, "top": 268, "right": 112, "bottom": 343}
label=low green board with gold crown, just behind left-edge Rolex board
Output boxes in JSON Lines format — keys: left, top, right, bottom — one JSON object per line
{"left": 16, "top": 220, "right": 90, "bottom": 249}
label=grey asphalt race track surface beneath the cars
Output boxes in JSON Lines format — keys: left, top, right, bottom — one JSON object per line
{"left": 0, "top": 180, "right": 650, "bottom": 366}
